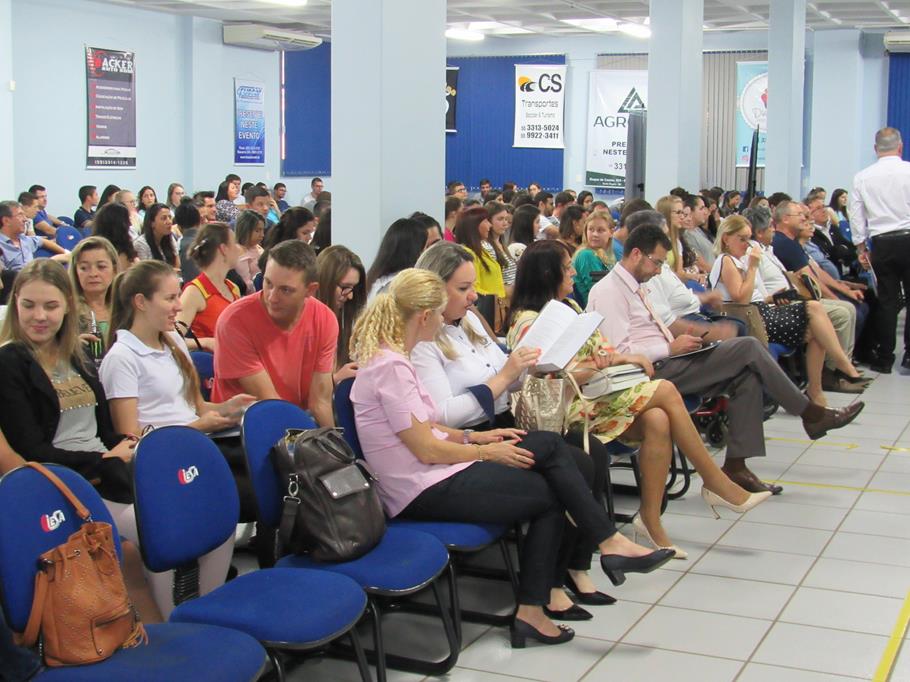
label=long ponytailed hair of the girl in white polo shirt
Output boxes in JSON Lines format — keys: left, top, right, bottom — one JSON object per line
{"left": 107, "top": 260, "right": 199, "bottom": 398}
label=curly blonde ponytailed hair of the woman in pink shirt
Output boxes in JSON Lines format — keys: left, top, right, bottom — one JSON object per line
{"left": 351, "top": 268, "right": 446, "bottom": 364}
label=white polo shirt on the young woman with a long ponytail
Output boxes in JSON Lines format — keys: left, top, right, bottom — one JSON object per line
{"left": 100, "top": 329, "right": 199, "bottom": 429}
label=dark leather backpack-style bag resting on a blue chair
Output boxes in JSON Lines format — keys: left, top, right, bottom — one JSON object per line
{"left": 272, "top": 428, "right": 385, "bottom": 561}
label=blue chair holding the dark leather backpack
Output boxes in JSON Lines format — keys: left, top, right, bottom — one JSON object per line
{"left": 241, "top": 400, "right": 460, "bottom": 682}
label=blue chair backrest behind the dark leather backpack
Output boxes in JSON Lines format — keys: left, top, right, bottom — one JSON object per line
{"left": 240, "top": 400, "right": 317, "bottom": 528}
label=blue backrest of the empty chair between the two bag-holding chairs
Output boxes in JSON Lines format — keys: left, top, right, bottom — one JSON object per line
{"left": 133, "top": 426, "right": 240, "bottom": 573}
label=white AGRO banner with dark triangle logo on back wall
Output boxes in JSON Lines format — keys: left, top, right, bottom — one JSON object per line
{"left": 585, "top": 70, "right": 648, "bottom": 189}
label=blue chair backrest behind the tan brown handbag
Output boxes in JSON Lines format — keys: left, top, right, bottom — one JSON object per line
{"left": 0, "top": 464, "right": 120, "bottom": 632}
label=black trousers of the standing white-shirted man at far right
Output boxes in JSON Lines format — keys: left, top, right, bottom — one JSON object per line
{"left": 871, "top": 234, "right": 910, "bottom": 362}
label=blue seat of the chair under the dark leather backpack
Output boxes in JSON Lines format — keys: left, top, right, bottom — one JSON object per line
{"left": 276, "top": 525, "right": 449, "bottom": 595}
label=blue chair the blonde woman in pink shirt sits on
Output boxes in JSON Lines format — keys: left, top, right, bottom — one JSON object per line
{"left": 334, "top": 379, "right": 518, "bottom": 640}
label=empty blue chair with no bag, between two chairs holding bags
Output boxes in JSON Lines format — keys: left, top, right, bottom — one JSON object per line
{"left": 133, "top": 426, "right": 372, "bottom": 681}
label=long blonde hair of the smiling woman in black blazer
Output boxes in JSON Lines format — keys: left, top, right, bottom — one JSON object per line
{"left": 0, "top": 258, "right": 88, "bottom": 368}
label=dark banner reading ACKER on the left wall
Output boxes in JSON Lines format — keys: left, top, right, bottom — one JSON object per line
{"left": 85, "top": 46, "right": 136, "bottom": 169}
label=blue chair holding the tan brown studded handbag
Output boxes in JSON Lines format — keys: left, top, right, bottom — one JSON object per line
{"left": 0, "top": 464, "right": 266, "bottom": 682}
